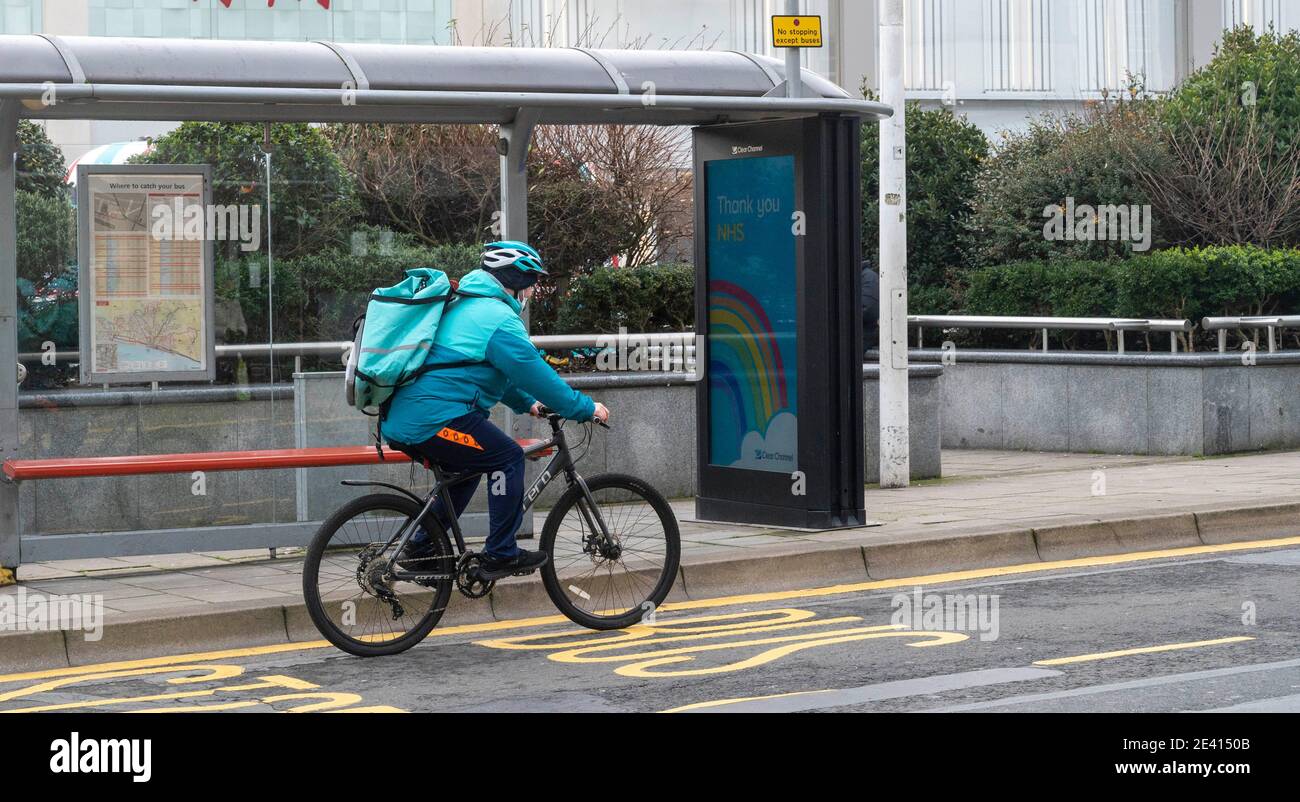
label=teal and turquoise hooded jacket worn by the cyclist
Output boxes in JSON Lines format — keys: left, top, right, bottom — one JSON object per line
{"left": 382, "top": 270, "right": 595, "bottom": 445}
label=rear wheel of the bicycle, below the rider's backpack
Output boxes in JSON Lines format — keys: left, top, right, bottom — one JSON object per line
{"left": 303, "top": 494, "right": 456, "bottom": 658}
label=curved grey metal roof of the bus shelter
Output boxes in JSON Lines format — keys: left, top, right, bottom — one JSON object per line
{"left": 0, "top": 34, "right": 892, "bottom": 125}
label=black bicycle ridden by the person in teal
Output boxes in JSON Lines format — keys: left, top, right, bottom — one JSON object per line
{"left": 303, "top": 408, "right": 681, "bottom": 656}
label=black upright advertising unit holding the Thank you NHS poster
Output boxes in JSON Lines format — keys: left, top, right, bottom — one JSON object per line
{"left": 696, "top": 116, "right": 865, "bottom": 529}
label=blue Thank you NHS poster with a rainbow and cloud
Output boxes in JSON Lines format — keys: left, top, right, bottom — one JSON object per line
{"left": 705, "top": 156, "right": 798, "bottom": 473}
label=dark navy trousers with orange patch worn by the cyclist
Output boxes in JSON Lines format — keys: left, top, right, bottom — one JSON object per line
{"left": 390, "top": 412, "right": 524, "bottom": 560}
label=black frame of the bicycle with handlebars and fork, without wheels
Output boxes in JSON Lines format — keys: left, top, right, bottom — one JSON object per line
{"left": 342, "top": 415, "right": 610, "bottom": 581}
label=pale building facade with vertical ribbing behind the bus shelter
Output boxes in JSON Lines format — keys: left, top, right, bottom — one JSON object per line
{"left": 0, "top": 0, "right": 1300, "bottom": 159}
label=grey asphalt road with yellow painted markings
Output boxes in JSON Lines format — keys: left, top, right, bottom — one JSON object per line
{"left": 0, "top": 535, "right": 1300, "bottom": 712}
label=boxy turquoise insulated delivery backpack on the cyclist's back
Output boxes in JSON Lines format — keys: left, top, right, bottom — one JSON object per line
{"left": 345, "top": 268, "right": 454, "bottom": 418}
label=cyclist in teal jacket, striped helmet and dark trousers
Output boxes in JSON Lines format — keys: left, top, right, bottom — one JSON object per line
{"left": 382, "top": 240, "right": 610, "bottom": 580}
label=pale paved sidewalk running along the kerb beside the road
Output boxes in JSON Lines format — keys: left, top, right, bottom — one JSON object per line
{"left": 0, "top": 451, "right": 1300, "bottom": 665}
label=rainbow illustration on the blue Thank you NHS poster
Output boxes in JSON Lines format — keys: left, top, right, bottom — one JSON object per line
{"left": 709, "top": 279, "right": 793, "bottom": 459}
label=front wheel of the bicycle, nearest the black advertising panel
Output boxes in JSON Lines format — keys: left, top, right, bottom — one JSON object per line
{"left": 541, "top": 473, "right": 681, "bottom": 629}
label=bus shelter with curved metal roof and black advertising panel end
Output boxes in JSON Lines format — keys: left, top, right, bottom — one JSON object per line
{"left": 0, "top": 35, "right": 891, "bottom": 567}
